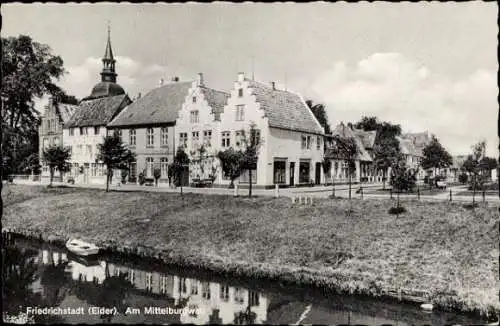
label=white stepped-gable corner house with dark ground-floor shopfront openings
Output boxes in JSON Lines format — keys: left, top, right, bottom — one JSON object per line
{"left": 212, "top": 73, "right": 324, "bottom": 187}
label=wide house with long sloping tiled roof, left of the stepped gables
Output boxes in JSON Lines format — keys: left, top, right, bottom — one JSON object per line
{"left": 108, "top": 77, "right": 195, "bottom": 184}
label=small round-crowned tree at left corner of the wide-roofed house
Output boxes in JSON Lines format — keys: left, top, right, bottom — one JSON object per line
{"left": 97, "top": 132, "right": 135, "bottom": 192}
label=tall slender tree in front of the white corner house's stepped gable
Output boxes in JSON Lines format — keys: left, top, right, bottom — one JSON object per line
{"left": 241, "top": 123, "right": 263, "bottom": 197}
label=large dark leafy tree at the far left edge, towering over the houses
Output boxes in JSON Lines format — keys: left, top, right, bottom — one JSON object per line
{"left": 1, "top": 35, "right": 65, "bottom": 178}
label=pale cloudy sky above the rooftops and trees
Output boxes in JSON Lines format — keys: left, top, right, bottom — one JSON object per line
{"left": 1, "top": 1, "right": 499, "bottom": 156}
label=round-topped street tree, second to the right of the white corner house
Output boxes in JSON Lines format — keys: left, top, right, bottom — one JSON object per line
{"left": 373, "top": 137, "right": 401, "bottom": 189}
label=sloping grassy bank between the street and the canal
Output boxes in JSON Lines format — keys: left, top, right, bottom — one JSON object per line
{"left": 3, "top": 185, "right": 500, "bottom": 312}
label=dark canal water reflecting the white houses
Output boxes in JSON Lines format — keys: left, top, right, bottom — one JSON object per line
{"left": 2, "top": 238, "right": 492, "bottom": 326}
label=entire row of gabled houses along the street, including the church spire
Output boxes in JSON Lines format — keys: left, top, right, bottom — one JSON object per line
{"left": 39, "top": 31, "right": 436, "bottom": 187}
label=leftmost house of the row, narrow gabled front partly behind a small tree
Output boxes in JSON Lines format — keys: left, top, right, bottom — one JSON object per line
{"left": 38, "top": 97, "right": 78, "bottom": 181}
